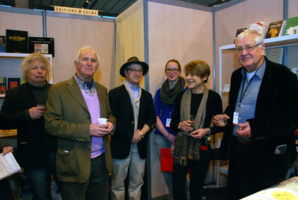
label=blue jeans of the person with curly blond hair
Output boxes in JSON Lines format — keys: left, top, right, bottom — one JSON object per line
{"left": 24, "top": 151, "right": 56, "bottom": 200}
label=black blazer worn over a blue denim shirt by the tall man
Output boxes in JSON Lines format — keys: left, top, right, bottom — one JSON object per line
{"left": 222, "top": 57, "right": 298, "bottom": 158}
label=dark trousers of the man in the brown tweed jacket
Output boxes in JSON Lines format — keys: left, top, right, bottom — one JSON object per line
{"left": 61, "top": 153, "right": 109, "bottom": 200}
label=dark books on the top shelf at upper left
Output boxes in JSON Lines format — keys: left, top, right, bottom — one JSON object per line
{"left": 0, "top": 29, "right": 55, "bottom": 57}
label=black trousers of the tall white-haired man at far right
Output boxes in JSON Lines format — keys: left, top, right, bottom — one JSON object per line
{"left": 226, "top": 138, "right": 291, "bottom": 200}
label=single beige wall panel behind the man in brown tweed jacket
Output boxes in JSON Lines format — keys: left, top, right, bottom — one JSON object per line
{"left": 47, "top": 15, "right": 115, "bottom": 89}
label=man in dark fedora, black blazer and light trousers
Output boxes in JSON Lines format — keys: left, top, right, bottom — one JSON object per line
{"left": 109, "top": 57, "right": 156, "bottom": 200}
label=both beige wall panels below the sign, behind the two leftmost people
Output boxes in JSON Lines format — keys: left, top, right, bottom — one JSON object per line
{"left": 0, "top": 8, "right": 115, "bottom": 89}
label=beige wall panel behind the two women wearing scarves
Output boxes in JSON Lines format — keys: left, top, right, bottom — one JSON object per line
{"left": 148, "top": 2, "right": 213, "bottom": 199}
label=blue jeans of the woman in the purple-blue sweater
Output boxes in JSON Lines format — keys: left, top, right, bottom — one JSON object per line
{"left": 154, "top": 134, "right": 173, "bottom": 199}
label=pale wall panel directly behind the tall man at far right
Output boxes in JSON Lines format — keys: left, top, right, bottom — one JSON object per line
{"left": 215, "top": 0, "right": 283, "bottom": 109}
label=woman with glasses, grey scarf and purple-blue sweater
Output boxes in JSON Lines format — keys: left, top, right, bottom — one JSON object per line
{"left": 154, "top": 59, "right": 185, "bottom": 199}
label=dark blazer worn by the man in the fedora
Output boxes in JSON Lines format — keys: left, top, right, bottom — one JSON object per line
{"left": 109, "top": 85, "right": 156, "bottom": 159}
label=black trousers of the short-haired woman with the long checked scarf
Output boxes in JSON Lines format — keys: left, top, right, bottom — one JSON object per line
{"left": 173, "top": 150, "right": 210, "bottom": 200}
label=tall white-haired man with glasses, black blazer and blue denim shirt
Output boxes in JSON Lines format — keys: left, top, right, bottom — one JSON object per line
{"left": 214, "top": 30, "right": 298, "bottom": 200}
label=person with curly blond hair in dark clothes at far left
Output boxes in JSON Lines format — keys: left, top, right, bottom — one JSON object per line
{"left": 0, "top": 53, "right": 57, "bottom": 200}
